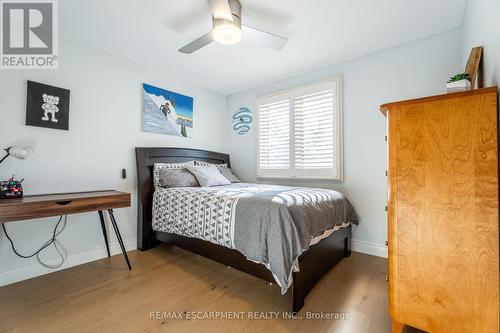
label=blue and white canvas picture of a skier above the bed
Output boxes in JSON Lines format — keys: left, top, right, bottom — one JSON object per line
{"left": 142, "top": 83, "right": 193, "bottom": 137}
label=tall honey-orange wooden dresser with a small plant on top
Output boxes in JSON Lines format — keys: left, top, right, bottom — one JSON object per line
{"left": 381, "top": 87, "right": 499, "bottom": 333}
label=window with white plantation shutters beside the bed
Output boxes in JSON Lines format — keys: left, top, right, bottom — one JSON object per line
{"left": 257, "top": 77, "right": 342, "bottom": 180}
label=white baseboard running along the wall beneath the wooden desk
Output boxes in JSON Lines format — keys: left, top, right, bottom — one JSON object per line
{"left": 0, "top": 239, "right": 137, "bottom": 286}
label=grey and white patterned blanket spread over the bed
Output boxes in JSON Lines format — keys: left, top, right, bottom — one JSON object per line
{"left": 153, "top": 183, "right": 358, "bottom": 293}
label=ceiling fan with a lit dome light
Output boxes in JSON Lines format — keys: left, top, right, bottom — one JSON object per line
{"left": 179, "top": 0, "right": 288, "bottom": 54}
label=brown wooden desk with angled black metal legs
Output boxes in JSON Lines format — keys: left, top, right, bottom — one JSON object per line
{"left": 0, "top": 191, "right": 132, "bottom": 269}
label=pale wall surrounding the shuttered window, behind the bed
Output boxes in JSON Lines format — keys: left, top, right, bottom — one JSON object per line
{"left": 228, "top": 30, "right": 461, "bottom": 256}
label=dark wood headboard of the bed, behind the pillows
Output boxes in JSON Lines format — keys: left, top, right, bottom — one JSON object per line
{"left": 135, "top": 147, "right": 230, "bottom": 251}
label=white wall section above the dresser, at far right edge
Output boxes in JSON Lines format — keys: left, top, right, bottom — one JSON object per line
{"left": 462, "top": 0, "right": 500, "bottom": 86}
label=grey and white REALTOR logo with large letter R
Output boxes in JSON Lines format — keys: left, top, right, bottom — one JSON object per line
{"left": 0, "top": 0, "right": 58, "bottom": 69}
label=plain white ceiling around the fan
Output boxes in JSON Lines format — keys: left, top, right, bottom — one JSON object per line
{"left": 59, "top": 0, "right": 467, "bottom": 95}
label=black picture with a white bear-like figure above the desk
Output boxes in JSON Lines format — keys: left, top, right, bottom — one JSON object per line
{"left": 26, "top": 81, "right": 69, "bottom": 131}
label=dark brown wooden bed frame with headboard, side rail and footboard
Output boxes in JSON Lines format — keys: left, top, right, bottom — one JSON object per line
{"left": 135, "top": 148, "right": 351, "bottom": 312}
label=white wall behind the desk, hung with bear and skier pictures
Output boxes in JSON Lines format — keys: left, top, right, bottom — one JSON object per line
{"left": 0, "top": 40, "right": 227, "bottom": 285}
